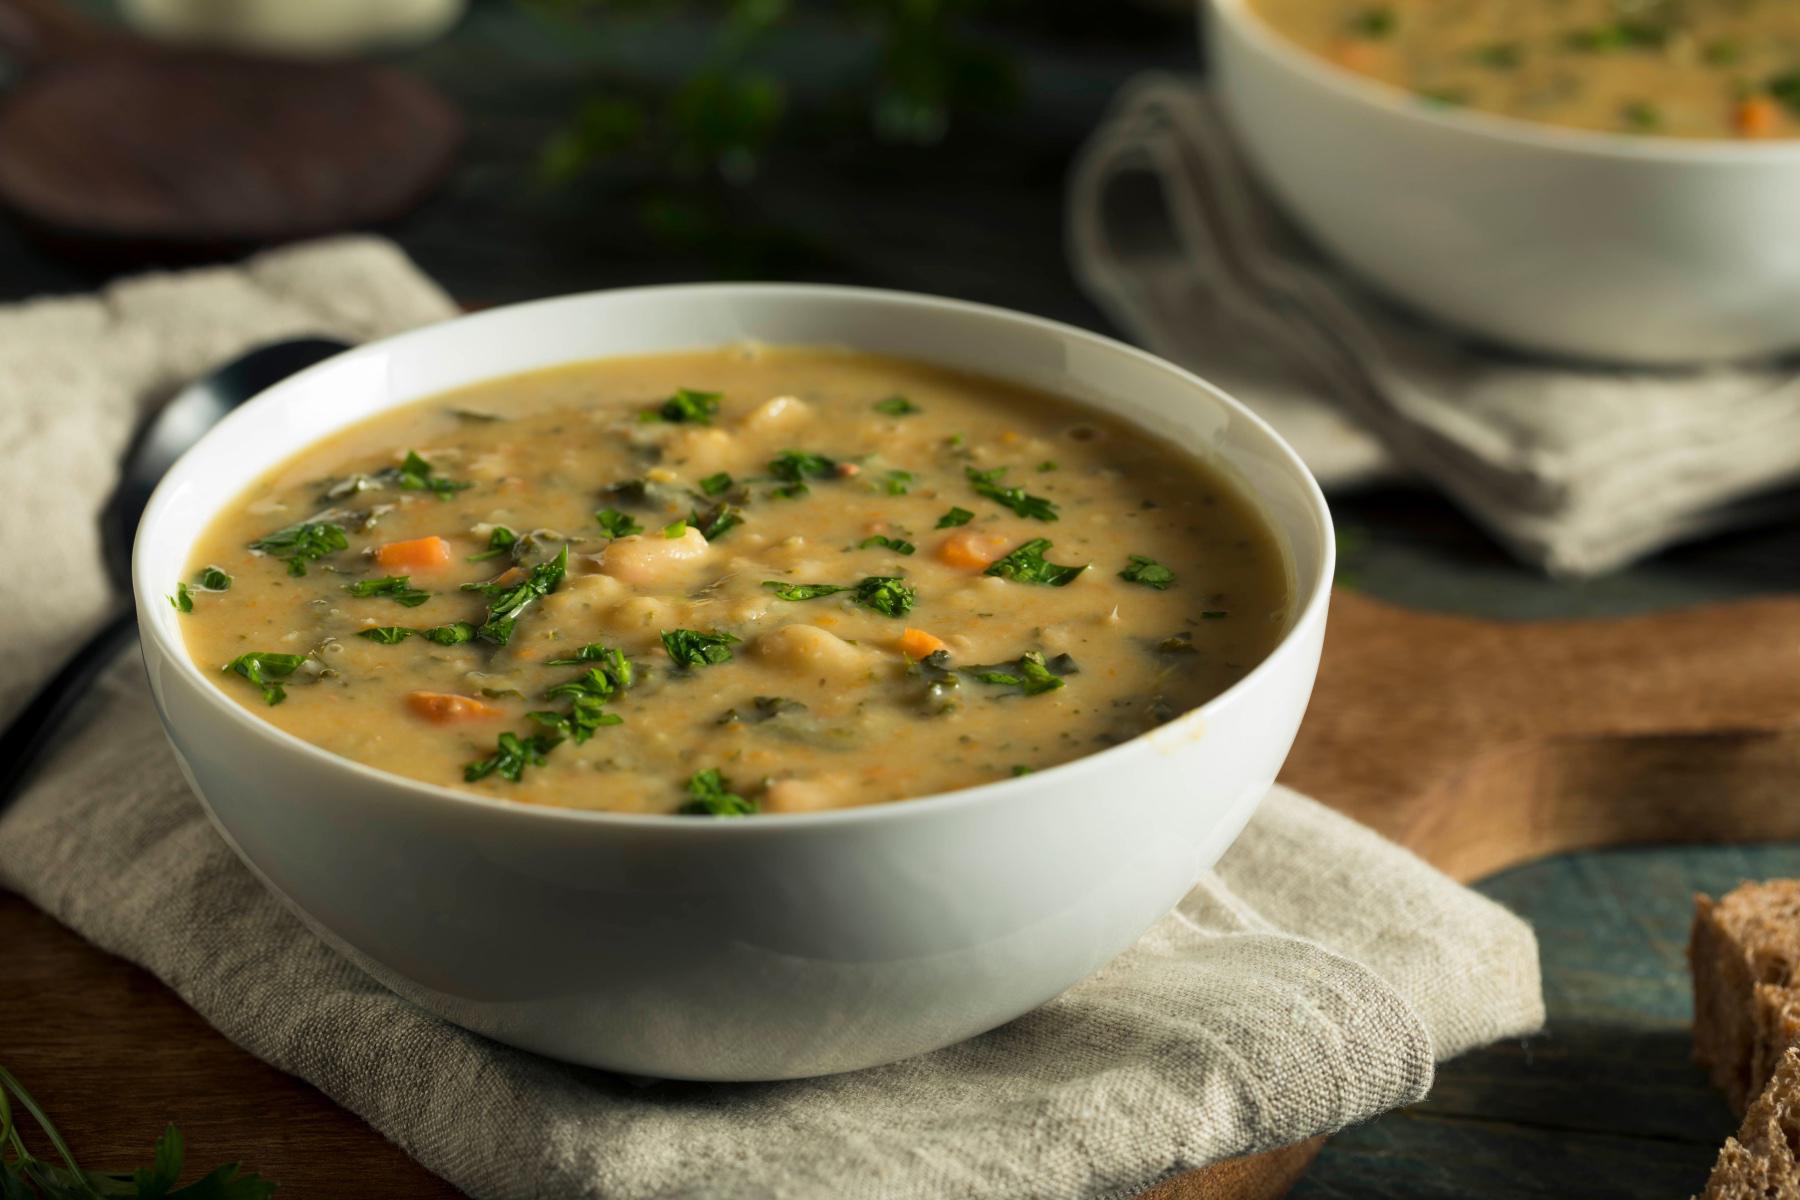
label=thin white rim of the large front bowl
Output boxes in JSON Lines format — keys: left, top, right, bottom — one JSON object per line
{"left": 131, "top": 282, "right": 1337, "bottom": 837}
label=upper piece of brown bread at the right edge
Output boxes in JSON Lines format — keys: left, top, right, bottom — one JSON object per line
{"left": 1688, "top": 880, "right": 1800, "bottom": 1112}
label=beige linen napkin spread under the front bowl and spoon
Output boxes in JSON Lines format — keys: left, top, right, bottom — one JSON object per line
{"left": 0, "top": 239, "right": 1543, "bottom": 1200}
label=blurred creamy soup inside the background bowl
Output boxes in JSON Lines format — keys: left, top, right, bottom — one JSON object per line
{"left": 1251, "top": 0, "right": 1800, "bottom": 139}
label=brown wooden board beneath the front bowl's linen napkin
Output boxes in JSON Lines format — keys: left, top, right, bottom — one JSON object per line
{"left": 10, "top": 592, "right": 1800, "bottom": 1200}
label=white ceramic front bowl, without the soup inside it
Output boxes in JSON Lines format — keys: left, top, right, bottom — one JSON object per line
{"left": 133, "top": 284, "right": 1332, "bottom": 1079}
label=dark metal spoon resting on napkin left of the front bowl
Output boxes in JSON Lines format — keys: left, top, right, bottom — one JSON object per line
{"left": 0, "top": 338, "right": 349, "bottom": 808}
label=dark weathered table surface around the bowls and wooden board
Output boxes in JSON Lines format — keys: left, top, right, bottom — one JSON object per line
{"left": 0, "top": 0, "right": 1800, "bottom": 1198}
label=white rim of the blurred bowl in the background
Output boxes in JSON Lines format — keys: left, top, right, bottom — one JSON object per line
{"left": 1199, "top": 0, "right": 1800, "bottom": 164}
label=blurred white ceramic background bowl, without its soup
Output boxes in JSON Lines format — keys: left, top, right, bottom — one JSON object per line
{"left": 1206, "top": 0, "right": 1800, "bottom": 365}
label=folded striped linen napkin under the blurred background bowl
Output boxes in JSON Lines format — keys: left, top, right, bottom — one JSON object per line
{"left": 1069, "top": 74, "right": 1800, "bottom": 576}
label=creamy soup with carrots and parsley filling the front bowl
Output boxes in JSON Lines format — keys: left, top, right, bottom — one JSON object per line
{"left": 171, "top": 347, "right": 1287, "bottom": 815}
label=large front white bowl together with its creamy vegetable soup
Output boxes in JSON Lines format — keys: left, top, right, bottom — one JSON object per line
{"left": 133, "top": 286, "right": 1332, "bottom": 1079}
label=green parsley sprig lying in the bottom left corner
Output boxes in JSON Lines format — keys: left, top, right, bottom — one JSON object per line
{"left": 0, "top": 1067, "right": 275, "bottom": 1200}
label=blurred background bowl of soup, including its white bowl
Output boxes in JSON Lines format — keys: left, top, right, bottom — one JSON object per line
{"left": 1206, "top": 0, "right": 1800, "bottom": 365}
